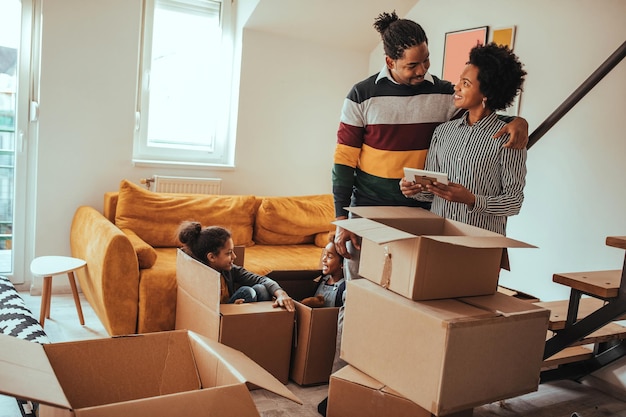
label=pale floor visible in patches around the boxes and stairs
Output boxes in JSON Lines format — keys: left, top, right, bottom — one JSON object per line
{"left": 0, "top": 293, "right": 626, "bottom": 417}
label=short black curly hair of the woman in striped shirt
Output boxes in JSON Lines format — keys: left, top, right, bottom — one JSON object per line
{"left": 467, "top": 42, "right": 526, "bottom": 111}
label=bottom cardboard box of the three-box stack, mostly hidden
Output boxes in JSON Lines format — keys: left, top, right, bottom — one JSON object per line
{"left": 326, "top": 365, "right": 473, "bottom": 417}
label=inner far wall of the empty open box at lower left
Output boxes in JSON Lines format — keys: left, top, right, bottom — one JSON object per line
{"left": 44, "top": 331, "right": 201, "bottom": 409}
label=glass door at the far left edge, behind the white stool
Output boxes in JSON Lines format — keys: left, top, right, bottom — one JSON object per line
{"left": 0, "top": 0, "right": 39, "bottom": 283}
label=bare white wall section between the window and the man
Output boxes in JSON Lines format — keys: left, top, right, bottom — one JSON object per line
{"left": 232, "top": 30, "right": 368, "bottom": 195}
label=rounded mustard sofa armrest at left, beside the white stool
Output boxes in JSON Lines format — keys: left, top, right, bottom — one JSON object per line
{"left": 70, "top": 206, "right": 139, "bottom": 336}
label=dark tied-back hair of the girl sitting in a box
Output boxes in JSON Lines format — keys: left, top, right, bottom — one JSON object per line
{"left": 178, "top": 221, "right": 231, "bottom": 264}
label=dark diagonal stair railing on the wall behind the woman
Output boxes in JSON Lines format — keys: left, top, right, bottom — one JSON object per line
{"left": 527, "top": 42, "right": 626, "bottom": 149}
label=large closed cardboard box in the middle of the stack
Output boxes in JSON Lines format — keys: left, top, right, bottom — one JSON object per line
{"left": 341, "top": 279, "right": 550, "bottom": 416}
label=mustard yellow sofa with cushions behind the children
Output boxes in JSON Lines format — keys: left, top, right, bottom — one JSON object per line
{"left": 70, "top": 180, "right": 334, "bottom": 336}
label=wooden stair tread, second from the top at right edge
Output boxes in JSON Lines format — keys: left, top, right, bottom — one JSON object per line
{"left": 552, "top": 269, "right": 622, "bottom": 299}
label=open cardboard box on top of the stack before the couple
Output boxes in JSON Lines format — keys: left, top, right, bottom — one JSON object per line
{"left": 334, "top": 207, "right": 533, "bottom": 300}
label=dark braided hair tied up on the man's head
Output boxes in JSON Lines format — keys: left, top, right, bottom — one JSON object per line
{"left": 374, "top": 10, "right": 428, "bottom": 60}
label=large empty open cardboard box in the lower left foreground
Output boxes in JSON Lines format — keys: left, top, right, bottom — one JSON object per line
{"left": 0, "top": 331, "right": 302, "bottom": 417}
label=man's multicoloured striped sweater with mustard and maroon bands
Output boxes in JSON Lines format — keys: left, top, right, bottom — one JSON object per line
{"left": 332, "top": 68, "right": 457, "bottom": 217}
